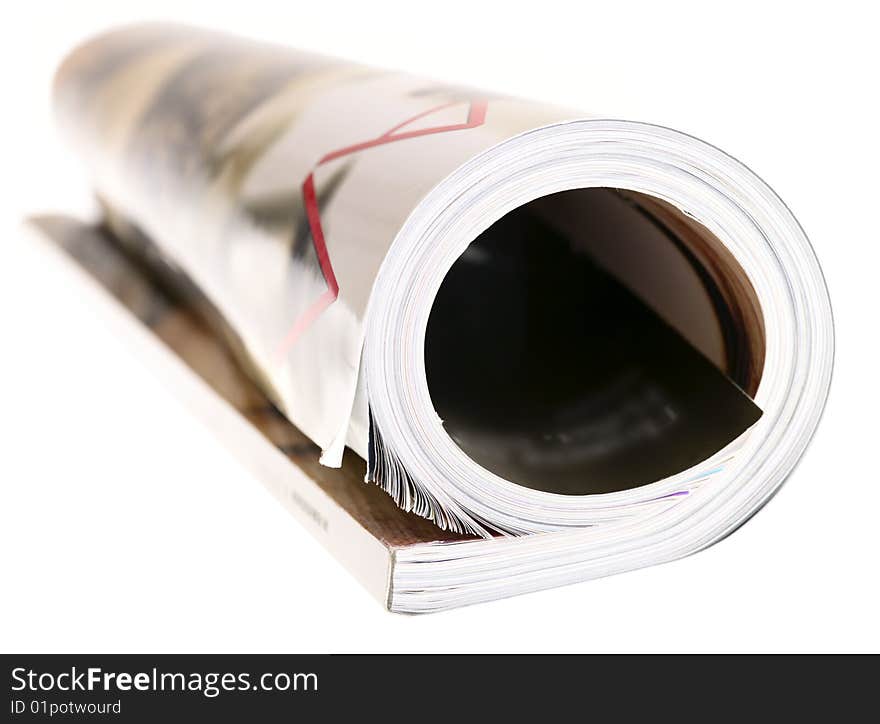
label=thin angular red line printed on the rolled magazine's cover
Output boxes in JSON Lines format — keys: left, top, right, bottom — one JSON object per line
{"left": 277, "top": 99, "right": 489, "bottom": 357}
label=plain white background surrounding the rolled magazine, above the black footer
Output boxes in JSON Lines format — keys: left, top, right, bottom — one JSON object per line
{"left": 0, "top": 0, "right": 880, "bottom": 652}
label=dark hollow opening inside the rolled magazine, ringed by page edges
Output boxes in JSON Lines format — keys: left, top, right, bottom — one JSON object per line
{"left": 425, "top": 188, "right": 764, "bottom": 495}
